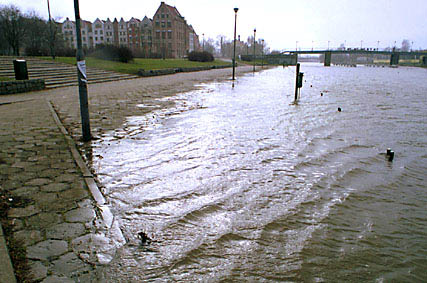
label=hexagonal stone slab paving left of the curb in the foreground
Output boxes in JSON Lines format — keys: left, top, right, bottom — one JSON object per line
{"left": 0, "top": 99, "right": 123, "bottom": 282}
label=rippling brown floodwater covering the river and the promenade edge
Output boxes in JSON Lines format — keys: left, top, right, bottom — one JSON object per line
{"left": 88, "top": 64, "right": 427, "bottom": 282}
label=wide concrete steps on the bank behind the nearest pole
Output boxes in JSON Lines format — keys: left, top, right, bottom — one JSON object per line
{"left": 0, "top": 57, "right": 139, "bottom": 88}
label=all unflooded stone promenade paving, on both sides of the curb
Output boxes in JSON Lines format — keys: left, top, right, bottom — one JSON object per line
{"left": 0, "top": 67, "right": 252, "bottom": 282}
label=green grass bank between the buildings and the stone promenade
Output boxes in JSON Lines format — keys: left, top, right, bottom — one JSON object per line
{"left": 41, "top": 57, "right": 230, "bottom": 74}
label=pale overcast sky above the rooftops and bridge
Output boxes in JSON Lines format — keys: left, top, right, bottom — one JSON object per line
{"left": 0, "top": 0, "right": 427, "bottom": 50}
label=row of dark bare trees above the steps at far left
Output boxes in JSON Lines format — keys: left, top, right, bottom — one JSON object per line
{"left": 0, "top": 5, "right": 64, "bottom": 57}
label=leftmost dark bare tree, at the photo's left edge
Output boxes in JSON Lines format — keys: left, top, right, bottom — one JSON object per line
{"left": 0, "top": 5, "right": 25, "bottom": 56}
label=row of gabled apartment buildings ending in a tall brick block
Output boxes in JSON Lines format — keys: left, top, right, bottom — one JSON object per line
{"left": 61, "top": 2, "right": 200, "bottom": 58}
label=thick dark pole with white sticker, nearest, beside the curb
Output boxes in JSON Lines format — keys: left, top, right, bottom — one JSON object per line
{"left": 74, "top": 0, "right": 92, "bottom": 141}
